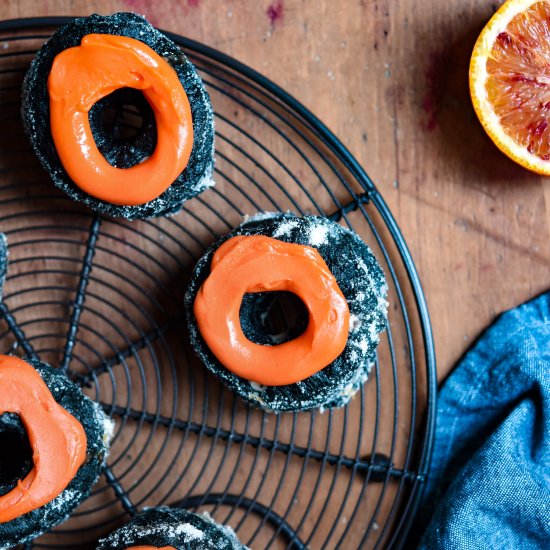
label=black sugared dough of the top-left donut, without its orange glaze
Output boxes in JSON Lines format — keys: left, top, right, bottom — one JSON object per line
{"left": 21, "top": 12, "right": 214, "bottom": 220}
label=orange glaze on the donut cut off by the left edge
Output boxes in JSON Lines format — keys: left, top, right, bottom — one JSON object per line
{"left": 0, "top": 355, "right": 87, "bottom": 523}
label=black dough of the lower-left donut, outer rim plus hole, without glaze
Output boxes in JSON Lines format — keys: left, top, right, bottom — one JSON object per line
{"left": 0, "top": 360, "right": 113, "bottom": 548}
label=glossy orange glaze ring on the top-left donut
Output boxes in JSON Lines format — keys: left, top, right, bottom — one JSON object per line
{"left": 48, "top": 34, "right": 193, "bottom": 206}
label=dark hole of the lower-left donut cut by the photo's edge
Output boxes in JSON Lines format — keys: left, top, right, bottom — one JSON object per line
{"left": 0, "top": 413, "right": 33, "bottom": 495}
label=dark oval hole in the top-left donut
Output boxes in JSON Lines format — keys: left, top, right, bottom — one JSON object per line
{"left": 88, "top": 88, "right": 157, "bottom": 168}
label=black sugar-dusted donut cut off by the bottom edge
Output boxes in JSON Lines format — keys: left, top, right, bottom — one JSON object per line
{"left": 97, "top": 506, "right": 246, "bottom": 550}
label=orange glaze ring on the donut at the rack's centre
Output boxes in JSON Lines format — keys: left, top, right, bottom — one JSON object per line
{"left": 194, "top": 235, "right": 349, "bottom": 386}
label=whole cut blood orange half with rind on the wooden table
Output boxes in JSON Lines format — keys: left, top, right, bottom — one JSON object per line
{"left": 470, "top": 0, "right": 550, "bottom": 175}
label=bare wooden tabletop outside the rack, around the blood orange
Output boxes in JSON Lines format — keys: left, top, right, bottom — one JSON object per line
{"left": 0, "top": 0, "right": 550, "bottom": 380}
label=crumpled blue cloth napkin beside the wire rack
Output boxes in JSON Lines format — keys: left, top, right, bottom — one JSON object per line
{"left": 417, "top": 292, "right": 550, "bottom": 550}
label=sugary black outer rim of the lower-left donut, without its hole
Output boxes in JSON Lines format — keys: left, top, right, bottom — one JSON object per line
{"left": 0, "top": 360, "right": 113, "bottom": 548}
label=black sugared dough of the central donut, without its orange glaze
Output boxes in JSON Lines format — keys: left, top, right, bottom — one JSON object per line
{"left": 185, "top": 213, "right": 388, "bottom": 412}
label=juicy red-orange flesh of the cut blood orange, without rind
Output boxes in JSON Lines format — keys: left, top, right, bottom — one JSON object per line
{"left": 492, "top": 2, "right": 550, "bottom": 160}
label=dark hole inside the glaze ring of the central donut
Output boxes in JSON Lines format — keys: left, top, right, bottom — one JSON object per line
{"left": 239, "top": 291, "right": 309, "bottom": 346}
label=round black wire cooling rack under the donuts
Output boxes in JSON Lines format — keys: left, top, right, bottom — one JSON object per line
{"left": 0, "top": 18, "right": 436, "bottom": 549}
